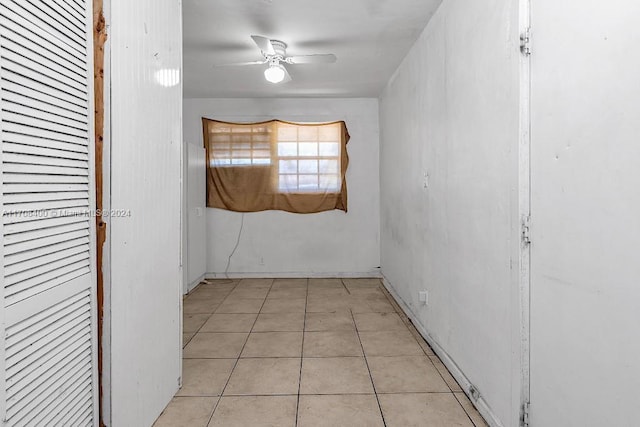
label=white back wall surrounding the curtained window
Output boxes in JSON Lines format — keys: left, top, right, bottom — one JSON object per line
{"left": 184, "top": 99, "right": 380, "bottom": 277}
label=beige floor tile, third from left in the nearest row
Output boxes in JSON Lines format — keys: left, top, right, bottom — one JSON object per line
{"left": 298, "top": 394, "right": 384, "bottom": 427}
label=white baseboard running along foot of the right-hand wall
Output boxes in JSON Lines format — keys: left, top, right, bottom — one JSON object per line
{"left": 382, "top": 275, "right": 504, "bottom": 427}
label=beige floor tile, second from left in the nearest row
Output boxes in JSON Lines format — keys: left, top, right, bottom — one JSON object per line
{"left": 209, "top": 396, "right": 297, "bottom": 427}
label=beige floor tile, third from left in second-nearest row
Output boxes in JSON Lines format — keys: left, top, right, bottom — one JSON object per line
{"left": 300, "top": 357, "right": 376, "bottom": 394}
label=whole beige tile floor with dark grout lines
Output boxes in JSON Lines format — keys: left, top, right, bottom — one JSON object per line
{"left": 155, "top": 279, "right": 486, "bottom": 427}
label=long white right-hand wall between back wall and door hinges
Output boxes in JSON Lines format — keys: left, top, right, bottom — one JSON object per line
{"left": 380, "top": 0, "right": 520, "bottom": 426}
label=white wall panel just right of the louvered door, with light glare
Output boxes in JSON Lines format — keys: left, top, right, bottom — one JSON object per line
{"left": 105, "top": 0, "right": 182, "bottom": 427}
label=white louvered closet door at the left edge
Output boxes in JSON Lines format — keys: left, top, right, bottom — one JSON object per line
{"left": 0, "top": 0, "right": 97, "bottom": 426}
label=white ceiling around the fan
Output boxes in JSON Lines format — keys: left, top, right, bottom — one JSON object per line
{"left": 183, "top": 0, "right": 442, "bottom": 98}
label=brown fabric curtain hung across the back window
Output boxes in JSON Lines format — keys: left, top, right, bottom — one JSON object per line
{"left": 202, "top": 118, "right": 349, "bottom": 213}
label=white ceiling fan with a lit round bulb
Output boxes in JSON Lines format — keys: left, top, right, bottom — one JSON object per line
{"left": 216, "top": 36, "right": 337, "bottom": 83}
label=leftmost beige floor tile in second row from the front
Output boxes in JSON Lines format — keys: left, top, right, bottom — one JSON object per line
{"left": 176, "top": 359, "right": 236, "bottom": 396}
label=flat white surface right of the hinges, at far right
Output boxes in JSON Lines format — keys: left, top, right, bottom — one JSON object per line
{"left": 531, "top": 0, "right": 640, "bottom": 427}
